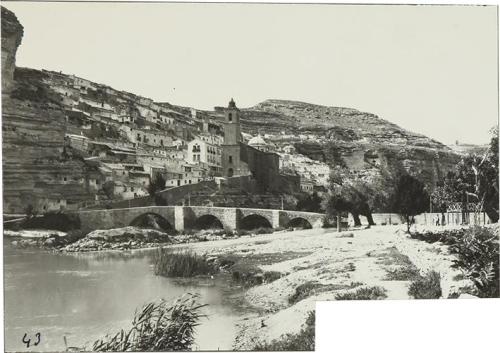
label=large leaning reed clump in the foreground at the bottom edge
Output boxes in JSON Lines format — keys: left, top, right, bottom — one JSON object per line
{"left": 92, "top": 294, "right": 205, "bottom": 352}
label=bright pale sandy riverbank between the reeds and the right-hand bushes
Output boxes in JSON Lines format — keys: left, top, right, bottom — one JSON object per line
{"left": 168, "top": 226, "right": 484, "bottom": 350}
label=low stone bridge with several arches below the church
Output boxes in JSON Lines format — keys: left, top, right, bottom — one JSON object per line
{"left": 75, "top": 206, "right": 323, "bottom": 232}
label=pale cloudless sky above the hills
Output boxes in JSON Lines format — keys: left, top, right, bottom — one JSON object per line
{"left": 2, "top": 2, "right": 498, "bottom": 144}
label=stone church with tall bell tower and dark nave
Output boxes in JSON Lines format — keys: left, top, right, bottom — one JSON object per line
{"left": 221, "top": 99, "right": 300, "bottom": 192}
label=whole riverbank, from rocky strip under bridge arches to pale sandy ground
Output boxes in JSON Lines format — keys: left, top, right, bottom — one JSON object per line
{"left": 5, "top": 221, "right": 494, "bottom": 350}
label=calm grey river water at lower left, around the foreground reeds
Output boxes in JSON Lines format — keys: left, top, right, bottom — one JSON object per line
{"left": 4, "top": 245, "right": 245, "bottom": 351}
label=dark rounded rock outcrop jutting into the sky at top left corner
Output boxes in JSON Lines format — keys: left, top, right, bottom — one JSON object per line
{"left": 2, "top": 6, "right": 23, "bottom": 95}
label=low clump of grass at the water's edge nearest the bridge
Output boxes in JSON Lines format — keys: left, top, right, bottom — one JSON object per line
{"left": 153, "top": 248, "right": 218, "bottom": 277}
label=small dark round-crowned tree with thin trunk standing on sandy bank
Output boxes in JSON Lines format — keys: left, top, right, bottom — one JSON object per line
{"left": 394, "top": 174, "right": 429, "bottom": 233}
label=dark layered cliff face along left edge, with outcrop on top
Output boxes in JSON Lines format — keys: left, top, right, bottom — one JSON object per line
{"left": 2, "top": 7, "right": 92, "bottom": 213}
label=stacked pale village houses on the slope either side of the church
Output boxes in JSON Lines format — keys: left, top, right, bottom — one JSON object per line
{"left": 3, "top": 58, "right": 340, "bottom": 212}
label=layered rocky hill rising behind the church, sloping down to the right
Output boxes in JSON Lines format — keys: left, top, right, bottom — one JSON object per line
{"left": 230, "top": 100, "right": 460, "bottom": 185}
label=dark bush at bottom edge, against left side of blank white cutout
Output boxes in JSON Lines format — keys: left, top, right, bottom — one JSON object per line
{"left": 252, "top": 311, "right": 316, "bottom": 351}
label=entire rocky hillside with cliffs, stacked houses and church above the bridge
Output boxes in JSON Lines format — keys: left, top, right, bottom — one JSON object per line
{"left": 2, "top": 8, "right": 458, "bottom": 213}
